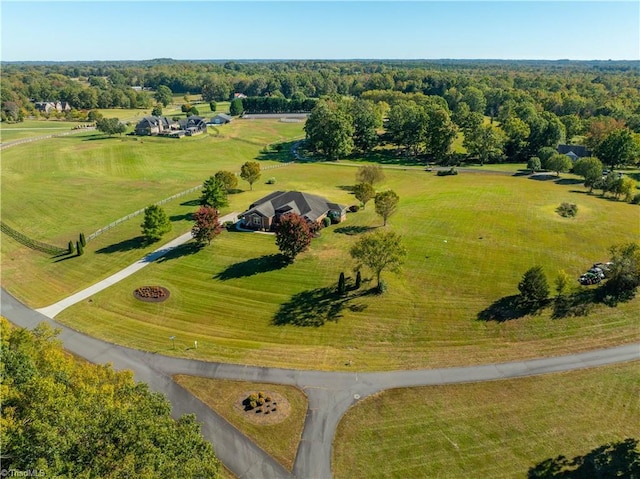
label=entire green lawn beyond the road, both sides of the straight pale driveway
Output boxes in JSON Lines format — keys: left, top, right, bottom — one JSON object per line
{"left": 2, "top": 120, "right": 639, "bottom": 370}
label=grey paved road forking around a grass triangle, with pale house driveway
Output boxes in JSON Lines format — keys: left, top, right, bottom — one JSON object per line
{"left": 0, "top": 227, "right": 640, "bottom": 479}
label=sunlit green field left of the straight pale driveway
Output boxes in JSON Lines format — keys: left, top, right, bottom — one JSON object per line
{"left": 1, "top": 121, "right": 302, "bottom": 306}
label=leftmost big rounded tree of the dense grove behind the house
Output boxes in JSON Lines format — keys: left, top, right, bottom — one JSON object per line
{"left": 304, "top": 100, "right": 354, "bottom": 160}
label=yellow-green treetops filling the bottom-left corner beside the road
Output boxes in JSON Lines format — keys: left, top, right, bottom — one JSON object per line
{"left": 0, "top": 318, "right": 220, "bottom": 479}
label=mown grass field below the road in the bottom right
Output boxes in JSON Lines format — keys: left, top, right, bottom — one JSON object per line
{"left": 333, "top": 362, "right": 640, "bottom": 479}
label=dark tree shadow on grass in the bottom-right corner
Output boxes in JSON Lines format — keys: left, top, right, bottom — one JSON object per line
{"left": 527, "top": 438, "right": 640, "bottom": 479}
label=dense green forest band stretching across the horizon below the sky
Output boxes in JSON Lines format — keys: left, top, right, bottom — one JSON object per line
{"left": 0, "top": 59, "right": 640, "bottom": 168}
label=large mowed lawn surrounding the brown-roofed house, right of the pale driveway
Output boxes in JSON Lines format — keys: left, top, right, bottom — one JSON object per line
{"left": 47, "top": 164, "right": 639, "bottom": 370}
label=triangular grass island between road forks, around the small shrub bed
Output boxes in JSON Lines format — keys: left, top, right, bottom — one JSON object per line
{"left": 174, "top": 375, "right": 307, "bottom": 470}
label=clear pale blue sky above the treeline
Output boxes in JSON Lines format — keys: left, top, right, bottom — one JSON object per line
{"left": 0, "top": 0, "right": 640, "bottom": 61}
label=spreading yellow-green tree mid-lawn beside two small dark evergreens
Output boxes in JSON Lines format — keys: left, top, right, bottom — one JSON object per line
{"left": 350, "top": 231, "right": 407, "bottom": 291}
